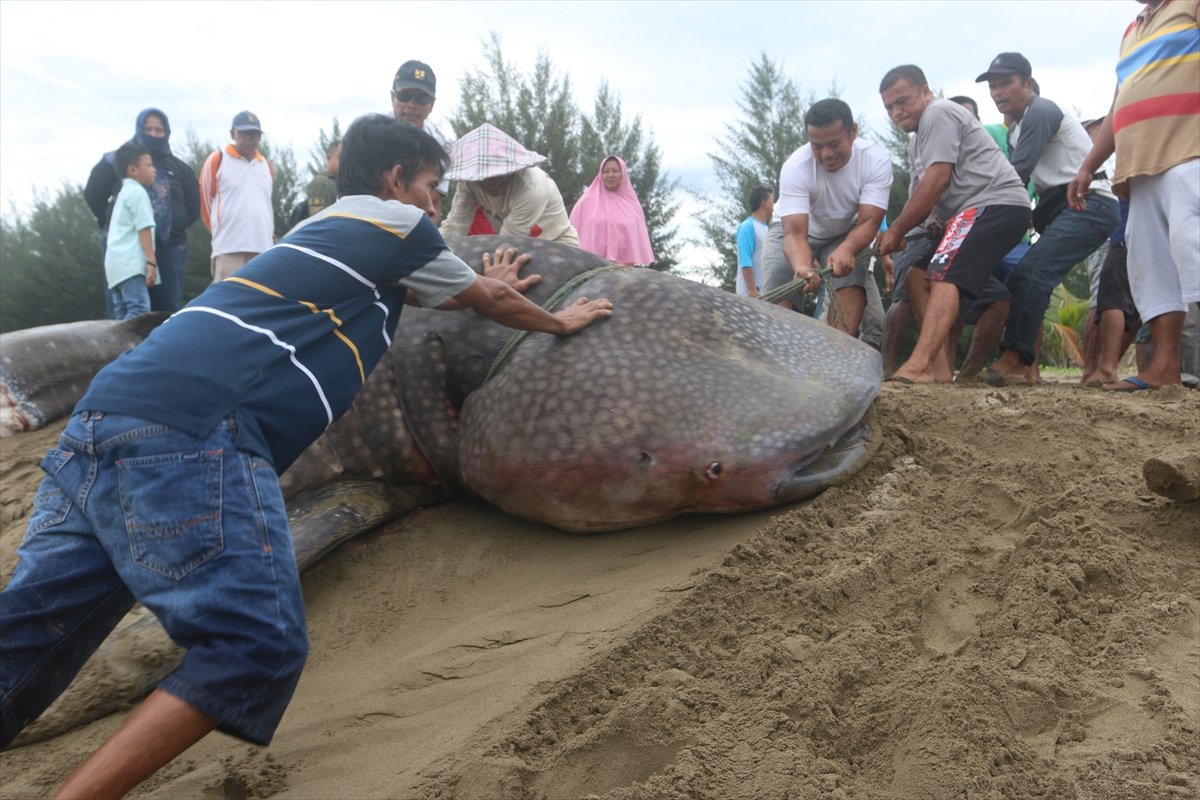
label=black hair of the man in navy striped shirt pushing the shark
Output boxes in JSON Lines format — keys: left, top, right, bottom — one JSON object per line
{"left": 337, "top": 114, "right": 450, "bottom": 197}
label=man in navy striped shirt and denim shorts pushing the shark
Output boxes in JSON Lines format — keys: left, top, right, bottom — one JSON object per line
{"left": 0, "top": 115, "right": 612, "bottom": 798}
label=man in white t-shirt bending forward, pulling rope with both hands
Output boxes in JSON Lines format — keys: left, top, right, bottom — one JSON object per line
{"left": 762, "top": 98, "right": 892, "bottom": 336}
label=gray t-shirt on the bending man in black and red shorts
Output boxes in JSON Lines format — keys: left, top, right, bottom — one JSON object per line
{"left": 908, "top": 100, "right": 1030, "bottom": 225}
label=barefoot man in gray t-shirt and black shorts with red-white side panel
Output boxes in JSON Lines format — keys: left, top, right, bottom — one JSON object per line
{"left": 880, "top": 65, "right": 1030, "bottom": 384}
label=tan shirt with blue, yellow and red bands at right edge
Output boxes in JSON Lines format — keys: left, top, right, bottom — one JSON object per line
{"left": 1112, "top": 0, "right": 1200, "bottom": 185}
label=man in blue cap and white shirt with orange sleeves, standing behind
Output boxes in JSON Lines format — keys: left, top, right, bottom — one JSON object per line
{"left": 200, "top": 112, "right": 275, "bottom": 283}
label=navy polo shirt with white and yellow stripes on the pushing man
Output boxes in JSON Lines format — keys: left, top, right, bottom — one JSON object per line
{"left": 76, "top": 196, "right": 476, "bottom": 473}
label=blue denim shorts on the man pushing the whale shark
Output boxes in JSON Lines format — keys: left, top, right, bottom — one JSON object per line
{"left": 0, "top": 411, "right": 308, "bottom": 746}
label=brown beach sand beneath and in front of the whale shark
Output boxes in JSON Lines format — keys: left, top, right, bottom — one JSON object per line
{"left": 0, "top": 385, "right": 1200, "bottom": 800}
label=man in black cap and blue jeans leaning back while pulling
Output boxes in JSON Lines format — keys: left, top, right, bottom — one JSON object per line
{"left": 976, "top": 53, "right": 1118, "bottom": 385}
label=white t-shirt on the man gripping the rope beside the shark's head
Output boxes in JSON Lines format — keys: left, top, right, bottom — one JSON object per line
{"left": 774, "top": 138, "right": 892, "bottom": 239}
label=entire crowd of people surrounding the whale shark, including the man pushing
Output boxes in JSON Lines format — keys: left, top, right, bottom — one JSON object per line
{"left": 0, "top": 0, "right": 1200, "bottom": 798}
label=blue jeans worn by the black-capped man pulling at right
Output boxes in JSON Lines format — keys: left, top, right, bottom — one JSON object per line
{"left": 1000, "top": 192, "right": 1120, "bottom": 365}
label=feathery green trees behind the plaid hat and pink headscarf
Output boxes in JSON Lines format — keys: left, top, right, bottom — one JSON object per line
{"left": 450, "top": 34, "right": 679, "bottom": 271}
